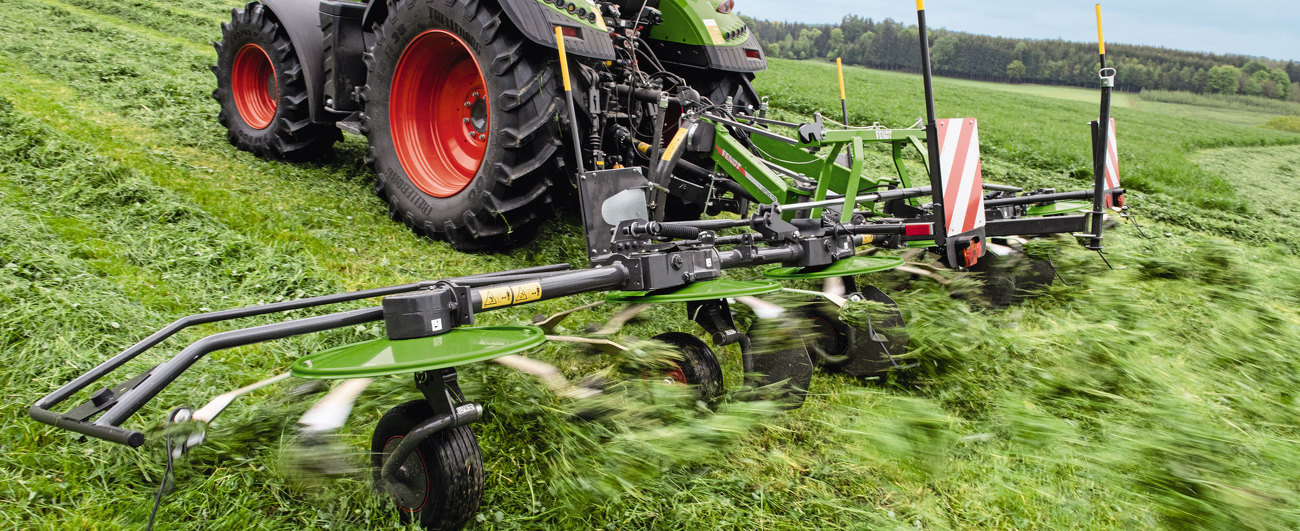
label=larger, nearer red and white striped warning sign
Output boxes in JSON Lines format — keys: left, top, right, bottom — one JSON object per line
{"left": 935, "top": 118, "right": 984, "bottom": 237}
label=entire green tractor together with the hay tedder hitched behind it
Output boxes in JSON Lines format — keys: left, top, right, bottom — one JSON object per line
{"left": 30, "top": 0, "right": 1125, "bottom": 528}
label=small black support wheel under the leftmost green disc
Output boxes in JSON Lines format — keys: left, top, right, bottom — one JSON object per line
{"left": 371, "top": 400, "right": 484, "bottom": 530}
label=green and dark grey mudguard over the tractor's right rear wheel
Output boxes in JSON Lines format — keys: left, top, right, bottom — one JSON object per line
{"left": 647, "top": 0, "right": 767, "bottom": 72}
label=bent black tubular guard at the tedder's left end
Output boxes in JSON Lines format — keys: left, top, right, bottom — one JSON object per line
{"left": 27, "top": 264, "right": 568, "bottom": 448}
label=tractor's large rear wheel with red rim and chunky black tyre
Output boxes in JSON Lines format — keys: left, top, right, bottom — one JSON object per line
{"left": 361, "top": 0, "right": 560, "bottom": 251}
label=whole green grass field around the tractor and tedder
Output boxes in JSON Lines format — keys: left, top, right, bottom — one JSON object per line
{"left": 0, "top": 0, "right": 1300, "bottom": 530}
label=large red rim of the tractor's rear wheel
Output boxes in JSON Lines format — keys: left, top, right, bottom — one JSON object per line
{"left": 389, "top": 30, "right": 490, "bottom": 198}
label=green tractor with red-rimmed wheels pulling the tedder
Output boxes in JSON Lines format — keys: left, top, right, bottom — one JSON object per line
{"left": 213, "top": 0, "right": 767, "bottom": 250}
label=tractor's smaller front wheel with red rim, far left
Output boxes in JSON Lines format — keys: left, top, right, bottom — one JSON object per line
{"left": 212, "top": 1, "right": 343, "bottom": 160}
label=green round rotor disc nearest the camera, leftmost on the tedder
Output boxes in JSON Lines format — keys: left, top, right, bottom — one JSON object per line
{"left": 290, "top": 327, "right": 546, "bottom": 379}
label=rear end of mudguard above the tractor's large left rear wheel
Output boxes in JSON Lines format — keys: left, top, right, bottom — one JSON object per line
{"left": 501, "top": 0, "right": 615, "bottom": 61}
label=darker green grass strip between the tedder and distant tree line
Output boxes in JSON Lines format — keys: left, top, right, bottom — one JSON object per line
{"left": 757, "top": 60, "right": 1297, "bottom": 213}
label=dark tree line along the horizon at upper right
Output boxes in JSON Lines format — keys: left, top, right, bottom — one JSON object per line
{"left": 746, "top": 14, "right": 1300, "bottom": 102}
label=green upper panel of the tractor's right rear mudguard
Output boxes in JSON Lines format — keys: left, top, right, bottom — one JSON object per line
{"left": 650, "top": 0, "right": 750, "bottom": 46}
